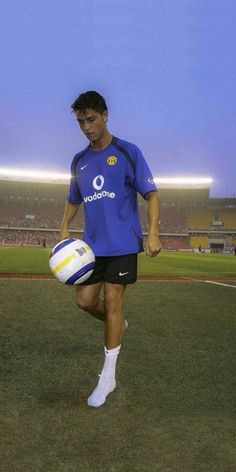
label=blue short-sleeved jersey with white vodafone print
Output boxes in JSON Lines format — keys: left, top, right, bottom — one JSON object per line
{"left": 68, "top": 137, "right": 156, "bottom": 256}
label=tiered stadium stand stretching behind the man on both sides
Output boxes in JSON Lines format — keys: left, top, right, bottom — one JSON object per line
{"left": 0, "top": 178, "right": 236, "bottom": 252}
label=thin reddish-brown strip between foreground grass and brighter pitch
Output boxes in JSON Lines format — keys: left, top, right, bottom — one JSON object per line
{"left": 0, "top": 272, "right": 236, "bottom": 282}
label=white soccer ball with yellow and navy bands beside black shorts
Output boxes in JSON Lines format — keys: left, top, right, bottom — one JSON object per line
{"left": 49, "top": 238, "right": 95, "bottom": 285}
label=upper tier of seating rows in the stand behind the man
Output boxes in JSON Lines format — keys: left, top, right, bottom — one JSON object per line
{"left": 0, "top": 201, "right": 236, "bottom": 238}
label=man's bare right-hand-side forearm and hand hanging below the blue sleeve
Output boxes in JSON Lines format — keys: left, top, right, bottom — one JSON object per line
{"left": 145, "top": 192, "right": 161, "bottom": 257}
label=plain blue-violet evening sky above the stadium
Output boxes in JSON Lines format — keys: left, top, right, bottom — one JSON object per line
{"left": 0, "top": 0, "right": 236, "bottom": 197}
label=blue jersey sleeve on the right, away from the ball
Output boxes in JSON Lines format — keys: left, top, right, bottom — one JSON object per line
{"left": 135, "top": 147, "right": 157, "bottom": 197}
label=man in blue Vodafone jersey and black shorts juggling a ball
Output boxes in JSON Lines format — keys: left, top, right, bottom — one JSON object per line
{"left": 60, "top": 91, "right": 161, "bottom": 407}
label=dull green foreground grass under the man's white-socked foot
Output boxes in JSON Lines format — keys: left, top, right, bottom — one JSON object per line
{"left": 0, "top": 278, "right": 236, "bottom": 472}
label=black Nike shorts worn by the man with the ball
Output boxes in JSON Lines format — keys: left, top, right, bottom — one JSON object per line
{"left": 80, "top": 254, "right": 137, "bottom": 285}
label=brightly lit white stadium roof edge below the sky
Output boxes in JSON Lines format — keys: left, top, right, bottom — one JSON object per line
{"left": 0, "top": 167, "right": 213, "bottom": 188}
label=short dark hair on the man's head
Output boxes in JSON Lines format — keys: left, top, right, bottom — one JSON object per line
{"left": 71, "top": 90, "right": 108, "bottom": 114}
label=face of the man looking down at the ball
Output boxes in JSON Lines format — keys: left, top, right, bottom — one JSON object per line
{"left": 76, "top": 108, "right": 107, "bottom": 143}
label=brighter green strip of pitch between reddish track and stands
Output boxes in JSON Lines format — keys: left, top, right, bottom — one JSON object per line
{"left": 0, "top": 247, "right": 236, "bottom": 276}
